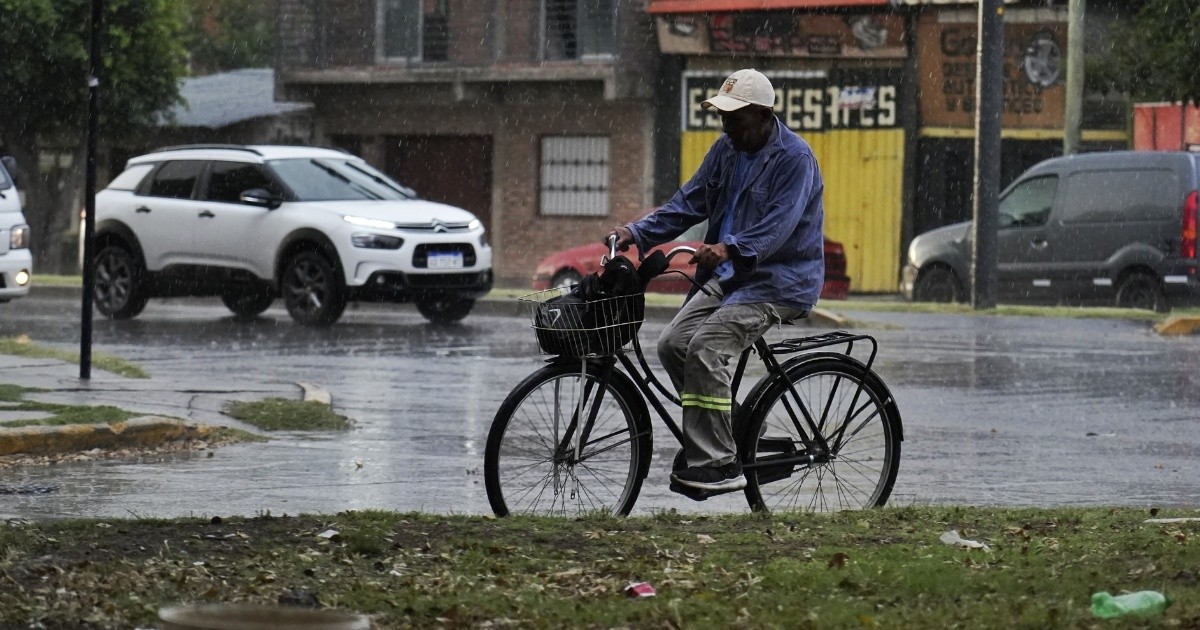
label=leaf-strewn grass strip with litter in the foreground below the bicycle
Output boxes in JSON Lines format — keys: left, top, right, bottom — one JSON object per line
{"left": 0, "top": 506, "right": 1200, "bottom": 629}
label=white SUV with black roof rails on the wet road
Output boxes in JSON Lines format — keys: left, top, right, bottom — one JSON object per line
{"left": 95, "top": 145, "right": 492, "bottom": 326}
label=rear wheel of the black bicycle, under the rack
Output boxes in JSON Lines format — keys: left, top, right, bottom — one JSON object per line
{"left": 742, "top": 356, "right": 901, "bottom": 512}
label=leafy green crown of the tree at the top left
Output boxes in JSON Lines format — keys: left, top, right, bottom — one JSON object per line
{"left": 0, "top": 0, "right": 185, "bottom": 139}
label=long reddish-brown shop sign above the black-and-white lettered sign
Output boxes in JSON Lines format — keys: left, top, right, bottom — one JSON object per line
{"left": 656, "top": 11, "right": 906, "bottom": 59}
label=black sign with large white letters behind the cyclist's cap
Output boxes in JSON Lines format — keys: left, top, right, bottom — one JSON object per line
{"left": 683, "top": 68, "right": 900, "bottom": 132}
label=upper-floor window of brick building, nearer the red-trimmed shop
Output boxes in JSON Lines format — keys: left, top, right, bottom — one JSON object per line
{"left": 541, "top": 0, "right": 617, "bottom": 60}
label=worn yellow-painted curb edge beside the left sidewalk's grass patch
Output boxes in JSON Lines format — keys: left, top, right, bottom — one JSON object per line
{"left": 0, "top": 415, "right": 216, "bottom": 456}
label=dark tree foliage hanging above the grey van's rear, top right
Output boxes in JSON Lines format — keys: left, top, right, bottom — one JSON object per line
{"left": 1087, "top": 0, "right": 1200, "bottom": 103}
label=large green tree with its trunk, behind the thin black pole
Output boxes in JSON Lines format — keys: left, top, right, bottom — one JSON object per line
{"left": 0, "top": 0, "right": 186, "bottom": 272}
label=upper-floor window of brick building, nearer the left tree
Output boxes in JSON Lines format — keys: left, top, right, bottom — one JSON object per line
{"left": 378, "top": 0, "right": 450, "bottom": 61}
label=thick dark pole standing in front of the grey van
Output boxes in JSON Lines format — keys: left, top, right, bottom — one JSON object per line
{"left": 971, "top": 0, "right": 1004, "bottom": 310}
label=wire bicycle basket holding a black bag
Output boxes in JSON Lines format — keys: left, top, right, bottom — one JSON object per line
{"left": 518, "top": 287, "right": 646, "bottom": 358}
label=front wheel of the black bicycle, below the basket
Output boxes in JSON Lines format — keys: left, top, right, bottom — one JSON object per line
{"left": 484, "top": 361, "right": 652, "bottom": 516}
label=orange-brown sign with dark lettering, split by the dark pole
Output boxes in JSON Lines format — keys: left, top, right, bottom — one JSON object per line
{"left": 917, "top": 10, "right": 1067, "bottom": 128}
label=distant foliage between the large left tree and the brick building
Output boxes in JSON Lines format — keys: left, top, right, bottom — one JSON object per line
{"left": 187, "top": 0, "right": 275, "bottom": 74}
